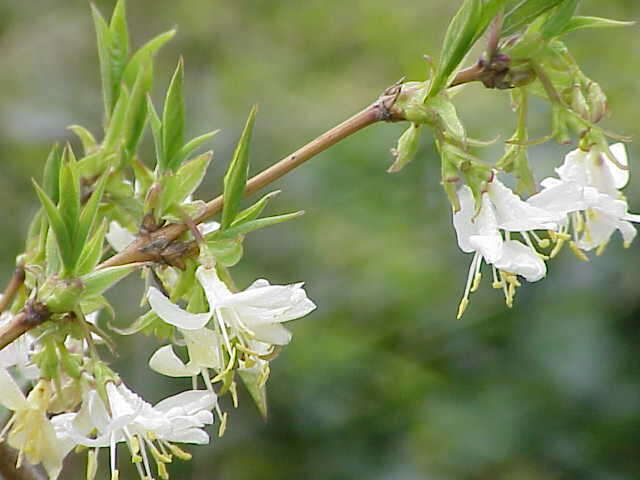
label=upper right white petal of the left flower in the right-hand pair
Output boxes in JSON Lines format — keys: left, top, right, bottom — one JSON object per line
{"left": 489, "top": 178, "right": 563, "bottom": 232}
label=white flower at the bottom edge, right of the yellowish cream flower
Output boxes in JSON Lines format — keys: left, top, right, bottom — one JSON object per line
{"left": 51, "top": 382, "right": 217, "bottom": 479}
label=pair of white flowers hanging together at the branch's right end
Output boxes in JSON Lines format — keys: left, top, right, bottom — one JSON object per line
{"left": 453, "top": 144, "right": 640, "bottom": 317}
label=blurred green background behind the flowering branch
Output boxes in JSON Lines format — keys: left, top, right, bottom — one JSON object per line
{"left": 0, "top": 0, "right": 640, "bottom": 480}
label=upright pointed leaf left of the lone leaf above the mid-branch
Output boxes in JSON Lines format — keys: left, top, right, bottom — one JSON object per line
{"left": 162, "top": 58, "right": 184, "bottom": 171}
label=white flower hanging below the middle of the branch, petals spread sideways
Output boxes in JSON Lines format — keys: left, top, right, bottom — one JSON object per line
{"left": 148, "top": 266, "right": 316, "bottom": 376}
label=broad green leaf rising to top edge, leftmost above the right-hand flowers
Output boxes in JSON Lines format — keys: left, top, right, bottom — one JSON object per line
{"left": 427, "top": 0, "right": 486, "bottom": 98}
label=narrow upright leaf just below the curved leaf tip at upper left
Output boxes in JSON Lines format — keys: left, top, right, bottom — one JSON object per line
{"left": 124, "top": 62, "right": 153, "bottom": 160}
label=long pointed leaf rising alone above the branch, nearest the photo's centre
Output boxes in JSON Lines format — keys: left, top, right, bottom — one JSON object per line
{"left": 220, "top": 106, "right": 257, "bottom": 229}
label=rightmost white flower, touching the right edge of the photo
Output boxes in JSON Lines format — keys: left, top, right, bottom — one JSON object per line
{"left": 527, "top": 143, "right": 640, "bottom": 253}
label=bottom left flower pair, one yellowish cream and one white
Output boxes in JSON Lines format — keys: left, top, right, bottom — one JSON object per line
{"left": 0, "top": 368, "right": 217, "bottom": 479}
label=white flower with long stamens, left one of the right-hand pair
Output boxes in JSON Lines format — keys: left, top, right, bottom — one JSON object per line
{"left": 453, "top": 176, "right": 561, "bottom": 318}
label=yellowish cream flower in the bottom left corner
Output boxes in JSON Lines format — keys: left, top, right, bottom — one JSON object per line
{"left": 0, "top": 368, "right": 75, "bottom": 479}
